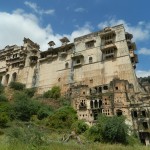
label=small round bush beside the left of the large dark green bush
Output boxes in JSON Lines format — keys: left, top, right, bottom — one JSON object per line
{"left": 71, "top": 120, "right": 88, "bottom": 134}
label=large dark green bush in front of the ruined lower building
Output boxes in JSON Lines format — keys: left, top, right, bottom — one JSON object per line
{"left": 88, "top": 115, "right": 128, "bottom": 144}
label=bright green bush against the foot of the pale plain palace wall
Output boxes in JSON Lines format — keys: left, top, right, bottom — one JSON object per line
{"left": 43, "top": 86, "right": 61, "bottom": 99}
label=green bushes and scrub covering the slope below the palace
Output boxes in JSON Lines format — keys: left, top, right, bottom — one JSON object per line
{"left": 0, "top": 83, "right": 142, "bottom": 149}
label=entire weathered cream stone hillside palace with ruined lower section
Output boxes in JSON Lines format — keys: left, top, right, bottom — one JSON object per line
{"left": 0, "top": 24, "right": 150, "bottom": 143}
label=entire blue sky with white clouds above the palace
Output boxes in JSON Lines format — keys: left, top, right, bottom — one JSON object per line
{"left": 0, "top": 0, "right": 150, "bottom": 76}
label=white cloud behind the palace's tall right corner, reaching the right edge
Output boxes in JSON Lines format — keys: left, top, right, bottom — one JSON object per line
{"left": 98, "top": 19, "right": 150, "bottom": 41}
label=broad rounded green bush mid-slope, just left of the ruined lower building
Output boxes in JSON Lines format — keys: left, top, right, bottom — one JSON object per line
{"left": 48, "top": 107, "right": 77, "bottom": 129}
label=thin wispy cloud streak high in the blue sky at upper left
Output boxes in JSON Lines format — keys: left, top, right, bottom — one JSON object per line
{"left": 24, "top": 1, "right": 55, "bottom": 15}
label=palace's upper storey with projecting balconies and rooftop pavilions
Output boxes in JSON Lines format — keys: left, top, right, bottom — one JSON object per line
{"left": 0, "top": 25, "right": 138, "bottom": 72}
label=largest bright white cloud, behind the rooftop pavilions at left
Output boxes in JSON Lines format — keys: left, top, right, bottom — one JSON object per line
{"left": 0, "top": 9, "right": 92, "bottom": 50}
